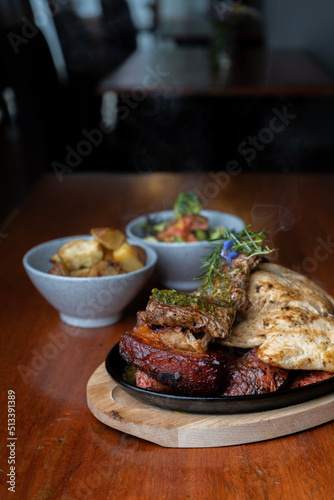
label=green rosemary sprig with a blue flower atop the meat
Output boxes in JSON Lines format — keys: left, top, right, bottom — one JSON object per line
{"left": 195, "top": 225, "right": 277, "bottom": 287}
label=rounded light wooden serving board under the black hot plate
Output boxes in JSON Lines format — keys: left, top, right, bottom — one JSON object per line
{"left": 87, "top": 363, "right": 334, "bottom": 448}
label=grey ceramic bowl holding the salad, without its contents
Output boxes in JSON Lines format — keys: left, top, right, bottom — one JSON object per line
{"left": 125, "top": 210, "right": 245, "bottom": 291}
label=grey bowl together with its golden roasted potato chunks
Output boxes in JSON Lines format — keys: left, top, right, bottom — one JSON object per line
{"left": 23, "top": 228, "right": 157, "bottom": 328}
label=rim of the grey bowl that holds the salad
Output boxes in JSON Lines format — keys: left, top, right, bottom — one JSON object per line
{"left": 125, "top": 209, "right": 246, "bottom": 248}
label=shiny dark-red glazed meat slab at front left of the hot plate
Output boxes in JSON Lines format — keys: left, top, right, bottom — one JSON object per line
{"left": 120, "top": 321, "right": 235, "bottom": 396}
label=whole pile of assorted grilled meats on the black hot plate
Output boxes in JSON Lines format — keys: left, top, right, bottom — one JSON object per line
{"left": 120, "top": 255, "right": 334, "bottom": 396}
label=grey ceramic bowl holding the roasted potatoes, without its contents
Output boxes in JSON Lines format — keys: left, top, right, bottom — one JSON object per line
{"left": 23, "top": 235, "right": 157, "bottom": 328}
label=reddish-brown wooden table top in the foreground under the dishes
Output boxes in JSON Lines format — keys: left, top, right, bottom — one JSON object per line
{"left": 0, "top": 172, "right": 334, "bottom": 500}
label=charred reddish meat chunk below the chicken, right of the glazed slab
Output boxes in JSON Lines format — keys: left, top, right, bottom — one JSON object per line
{"left": 221, "top": 349, "right": 289, "bottom": 396}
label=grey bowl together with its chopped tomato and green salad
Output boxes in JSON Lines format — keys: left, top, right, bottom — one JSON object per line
{"left": 125, "top": 192, "right": 245, "bottom": 291}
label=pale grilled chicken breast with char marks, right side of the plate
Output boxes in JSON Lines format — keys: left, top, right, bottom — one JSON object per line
{"left": 222, "top": 263, "right": 334, "bottom": 372}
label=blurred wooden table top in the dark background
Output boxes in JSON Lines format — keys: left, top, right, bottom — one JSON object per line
{"left": 97, "top": 47, "right": 334, "bottom": 97}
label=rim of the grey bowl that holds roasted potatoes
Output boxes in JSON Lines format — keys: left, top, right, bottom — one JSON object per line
{"left": 22, "top": 234, "right": 158, "bottom": 283}
